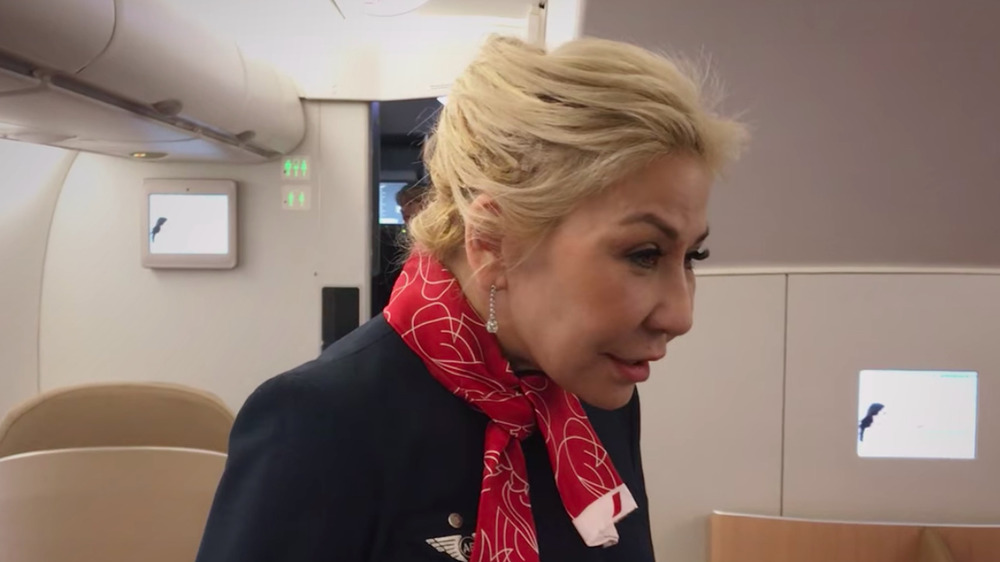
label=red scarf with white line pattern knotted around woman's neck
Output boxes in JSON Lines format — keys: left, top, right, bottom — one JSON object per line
{"left": 384, "top": 253, "right": 636, "bottom": 562}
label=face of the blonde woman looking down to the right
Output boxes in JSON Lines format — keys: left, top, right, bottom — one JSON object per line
{"left": 497, "top": 155, "right": 712, "bottom": 409}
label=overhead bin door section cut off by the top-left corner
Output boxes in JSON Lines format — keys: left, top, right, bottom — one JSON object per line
{"left": 0, "top": 0, "right": 115, "bottom": 73}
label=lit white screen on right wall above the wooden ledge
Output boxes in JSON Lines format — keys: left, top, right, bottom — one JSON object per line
{"left": 855, "top": 370, "right": 978, "bottom": 459}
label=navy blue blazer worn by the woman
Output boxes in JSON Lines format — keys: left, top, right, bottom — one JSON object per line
{"left": 197, "top": 316, "right": 653, "bottom": 562}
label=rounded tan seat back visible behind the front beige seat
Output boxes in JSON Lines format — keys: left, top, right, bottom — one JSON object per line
{"left": 0, "top": 383, "right": 233, "bottom": 458}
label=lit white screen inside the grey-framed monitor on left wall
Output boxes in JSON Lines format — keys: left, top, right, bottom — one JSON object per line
{"left": 149, "top": 193, "right": 229, "bottom": 255}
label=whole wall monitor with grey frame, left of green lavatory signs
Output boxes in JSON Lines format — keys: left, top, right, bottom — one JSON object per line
{"left": 141, "top": 179, "right": 237, "bottom": 269}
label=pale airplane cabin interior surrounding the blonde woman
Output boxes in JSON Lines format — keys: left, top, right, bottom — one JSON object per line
{"left": 0, "top": 0, "right": 1000, "bottom": 562}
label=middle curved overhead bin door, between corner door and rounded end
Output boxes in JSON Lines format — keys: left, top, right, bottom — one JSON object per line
{"left": 78, "top": 0, "right": 246, "bottom": 134}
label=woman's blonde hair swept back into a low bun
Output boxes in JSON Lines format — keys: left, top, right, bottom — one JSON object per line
{"left": 409, "top": 36, "right": 747, "bottom": 260}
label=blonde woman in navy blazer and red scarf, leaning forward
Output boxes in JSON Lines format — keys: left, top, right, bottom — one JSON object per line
{"left": 198, "top": 38, "right": 744, "bottom": 562}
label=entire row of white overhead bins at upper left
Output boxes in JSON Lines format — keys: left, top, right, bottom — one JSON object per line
{"left": 0, "top": 0, "right": 305, "bottom": 162}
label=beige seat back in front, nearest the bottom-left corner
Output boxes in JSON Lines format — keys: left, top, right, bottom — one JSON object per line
{"left": 0, "top": 447, "right": 226, "bottom": 562}
